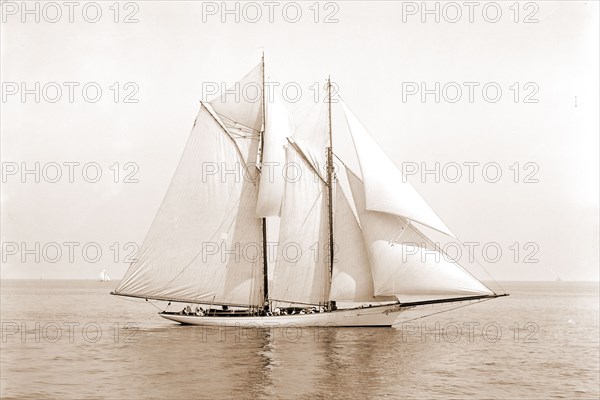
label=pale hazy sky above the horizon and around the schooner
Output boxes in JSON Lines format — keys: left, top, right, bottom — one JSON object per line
{"left": 1, "top": 1, "right": 600, "bottom": 280}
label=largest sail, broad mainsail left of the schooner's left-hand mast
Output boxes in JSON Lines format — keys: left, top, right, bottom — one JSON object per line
{"left": 116, "top": 104, "right": 263, "bottom": 305}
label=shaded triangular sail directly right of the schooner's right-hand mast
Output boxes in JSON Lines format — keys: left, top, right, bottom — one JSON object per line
{"left": 329, "top": 184, "right": 394, "bottom": 302}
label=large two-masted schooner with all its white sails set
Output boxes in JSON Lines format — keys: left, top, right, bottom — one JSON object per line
{"left": 111, "top": 56, "right": 505, "bottom": 327}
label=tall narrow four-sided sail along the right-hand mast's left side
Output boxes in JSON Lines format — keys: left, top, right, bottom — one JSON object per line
{"left": 270, "top": 146, "right": 329, "bottom": 304}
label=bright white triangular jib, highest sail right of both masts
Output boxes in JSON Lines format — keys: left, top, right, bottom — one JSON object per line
{"left": 342, "top": 102, "right": 454, "bottom": 236}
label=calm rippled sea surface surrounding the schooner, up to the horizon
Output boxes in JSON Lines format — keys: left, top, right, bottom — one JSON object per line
{"left": 0, "top": 280, "right": 600, "bottom": 399}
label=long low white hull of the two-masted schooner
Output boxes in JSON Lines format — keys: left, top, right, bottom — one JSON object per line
{"left": 159, "top": 304, "right": 402, "bottom": 328}
